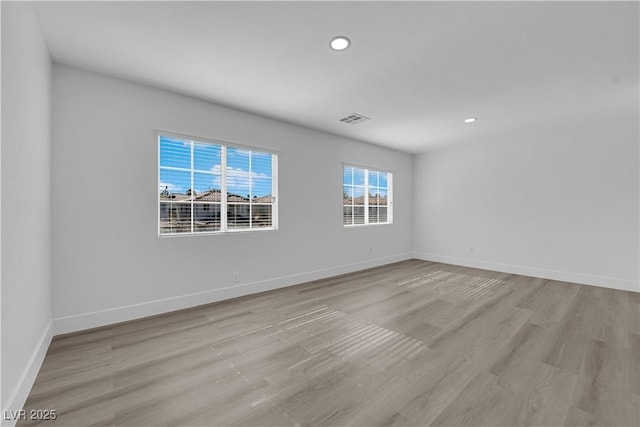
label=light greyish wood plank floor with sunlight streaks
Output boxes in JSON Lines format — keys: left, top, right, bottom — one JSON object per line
{"left": 18, "top": 260, "right": 640, "bottom": 426}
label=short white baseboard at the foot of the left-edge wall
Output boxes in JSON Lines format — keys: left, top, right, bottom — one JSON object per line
{"left": 2, "top": 321, "right": 53, "bottom": 427}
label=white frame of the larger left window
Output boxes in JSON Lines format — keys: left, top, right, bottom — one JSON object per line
{"left": 156, "top": 131, "right": 279, "bottom": 238}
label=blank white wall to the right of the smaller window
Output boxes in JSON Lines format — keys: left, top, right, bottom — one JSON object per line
{"left": 414, "top": 105, "right": 640, "bottom": 291}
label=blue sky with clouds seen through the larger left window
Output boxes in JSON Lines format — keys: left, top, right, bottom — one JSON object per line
{"left": 158, "top": 136, "right": 273, "bottom": 197}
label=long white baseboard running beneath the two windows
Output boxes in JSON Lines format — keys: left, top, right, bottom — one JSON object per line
{"left": 53, "top": 253, "right": 412, "bottom": 335}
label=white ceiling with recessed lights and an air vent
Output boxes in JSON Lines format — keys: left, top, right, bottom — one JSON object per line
{"left": 36, "top": 1, "right": 639, "bottom": 153}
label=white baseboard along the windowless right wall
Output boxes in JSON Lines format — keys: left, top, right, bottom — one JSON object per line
{"left": 413, "top": 252, "right": 640, "bottom": 292}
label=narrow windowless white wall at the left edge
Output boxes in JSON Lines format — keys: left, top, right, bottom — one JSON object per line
{"left": 1, "top": 2, "right": 51, "bottom": 424}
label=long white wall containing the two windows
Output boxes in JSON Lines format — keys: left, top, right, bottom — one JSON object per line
{"left": 52, "top": 65, "right": 413, "bottom": 333}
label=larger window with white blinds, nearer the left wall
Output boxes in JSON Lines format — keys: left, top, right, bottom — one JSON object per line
{"left": 158, "top": 134, "right": 278, "bottom": 235}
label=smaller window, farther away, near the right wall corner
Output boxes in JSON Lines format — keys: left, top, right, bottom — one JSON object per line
{"left": 342, "top": 165, "right": 393, "bottom": 226}
